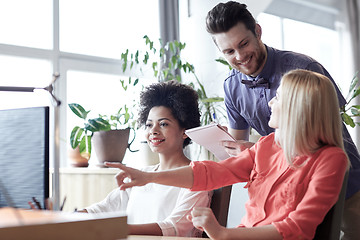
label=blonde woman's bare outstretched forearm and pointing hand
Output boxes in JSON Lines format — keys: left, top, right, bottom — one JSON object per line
{"left": 105, "top": 162, "right": 194, "bottom": 190}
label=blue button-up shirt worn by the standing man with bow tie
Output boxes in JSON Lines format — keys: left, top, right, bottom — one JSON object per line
{"left": 224, "top": 46, "right": 360, "bottom": 198}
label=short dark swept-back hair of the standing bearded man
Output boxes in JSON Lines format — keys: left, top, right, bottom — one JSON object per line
{"left": 206, "top": 1, "right": 256, "bottom": 35}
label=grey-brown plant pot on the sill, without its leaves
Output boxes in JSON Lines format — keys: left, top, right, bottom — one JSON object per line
{"left": 92, "top": 128, "right": 135, "bottom": 166}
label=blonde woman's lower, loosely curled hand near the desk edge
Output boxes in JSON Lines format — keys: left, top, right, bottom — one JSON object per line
{"left": 188, "top": 207, "right": 224, "bottom": 239}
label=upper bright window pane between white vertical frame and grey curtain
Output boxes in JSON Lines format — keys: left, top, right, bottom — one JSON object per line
{"left": 60, "top": 0, "right": 159, "bottom": 58}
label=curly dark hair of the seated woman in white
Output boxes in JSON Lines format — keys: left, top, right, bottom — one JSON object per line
{"left": 138, "top": 80, "right": 200, "bottom": 148}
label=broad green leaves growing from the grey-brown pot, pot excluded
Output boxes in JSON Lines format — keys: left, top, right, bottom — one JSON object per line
{"left": 68, "top": 103, "right": 135, "bottom": 159}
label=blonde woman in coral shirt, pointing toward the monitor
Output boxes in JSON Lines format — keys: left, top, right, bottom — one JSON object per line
{"left": 109, "top": 70, "right": 348, "bottom": 240}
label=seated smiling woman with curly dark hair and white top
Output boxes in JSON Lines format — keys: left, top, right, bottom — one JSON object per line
{"left": 82, "top": 81, "right": 211, "bottom": 237}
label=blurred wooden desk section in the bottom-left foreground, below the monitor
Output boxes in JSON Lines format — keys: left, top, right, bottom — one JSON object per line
{"left": 0, "top": 208, "right": 128, "bottom": 240}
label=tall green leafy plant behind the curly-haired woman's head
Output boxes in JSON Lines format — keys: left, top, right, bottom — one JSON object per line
{"left": 121, "top": 35, "right": 226, "bottom": 125}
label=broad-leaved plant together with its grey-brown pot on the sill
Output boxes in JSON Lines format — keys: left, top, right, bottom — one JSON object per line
{"left": 69, "top": 103, "right": 135, "bottom": 164}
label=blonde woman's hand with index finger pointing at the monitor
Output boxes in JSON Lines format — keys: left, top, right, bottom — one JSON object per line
{"left": 105, "top": 162, "right": 150, "bottom": 190}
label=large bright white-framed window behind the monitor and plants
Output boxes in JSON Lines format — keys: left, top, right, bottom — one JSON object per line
{"left": 0, "top": 0, "right": 160, "bottom": 166}
